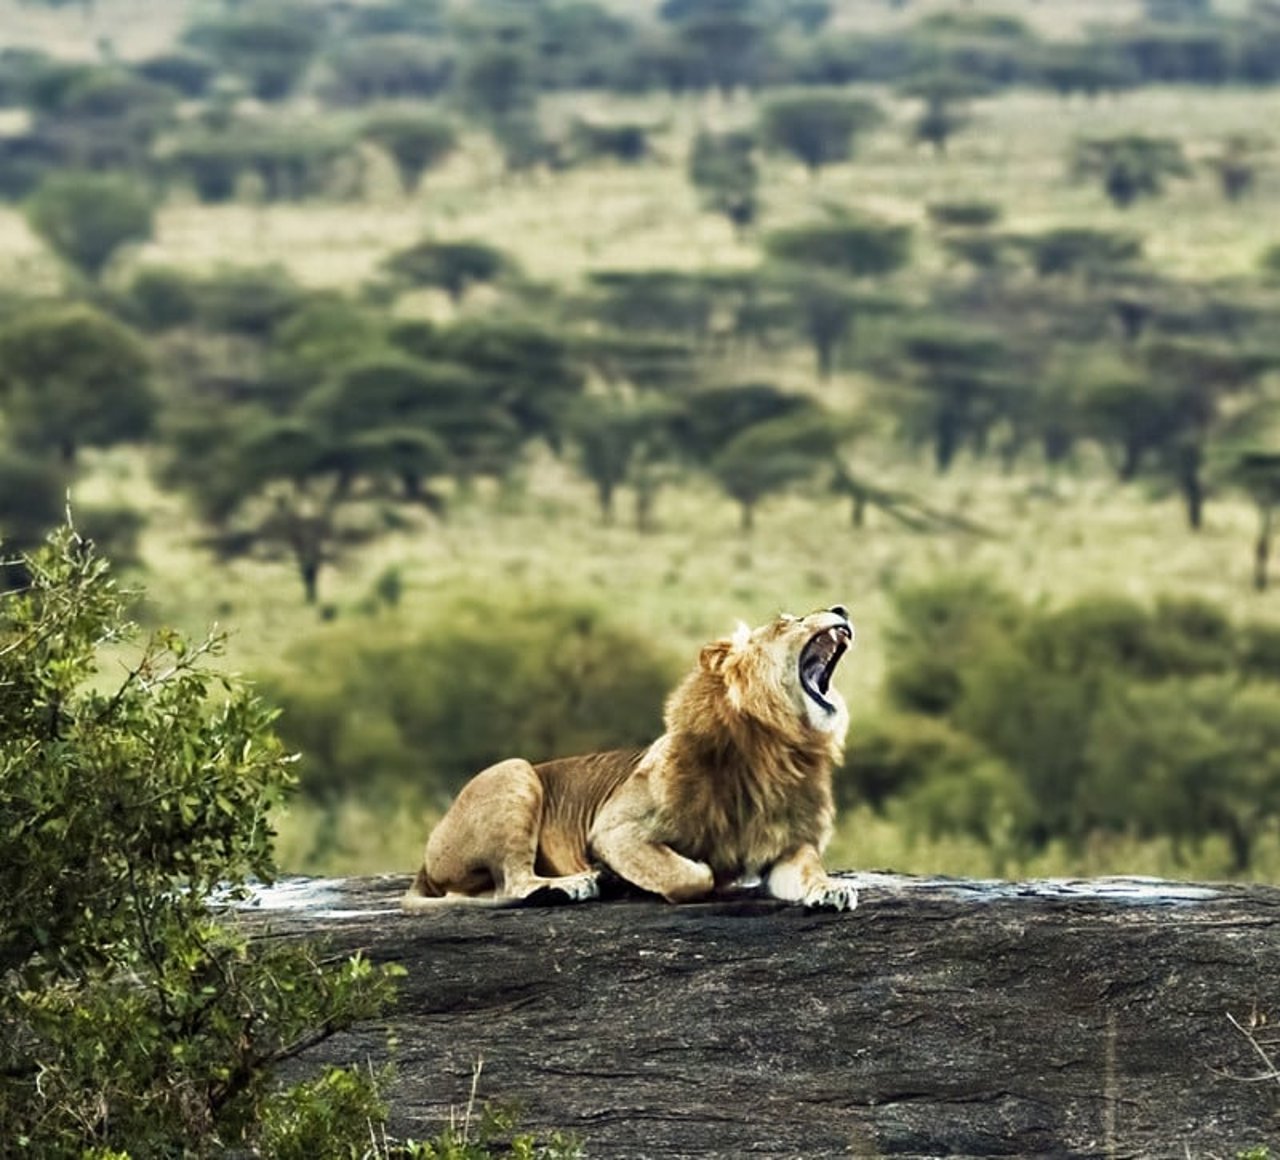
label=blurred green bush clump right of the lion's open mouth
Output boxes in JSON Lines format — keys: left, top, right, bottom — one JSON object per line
{"left": 875, "top": 577, "right": 1280, "bottom": 873}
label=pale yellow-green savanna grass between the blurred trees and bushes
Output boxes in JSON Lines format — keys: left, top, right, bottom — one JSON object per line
{"left": 0, "top": 0, "right": 1280, "bottom": 878}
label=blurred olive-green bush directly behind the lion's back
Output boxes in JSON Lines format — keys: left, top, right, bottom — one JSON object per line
{"left": 264, "top": 600, "right": 678, "bottom": 800}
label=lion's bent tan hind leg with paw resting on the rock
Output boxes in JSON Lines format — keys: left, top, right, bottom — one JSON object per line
{"left": 404, "top": 758, "right": 600, "bottom": 910}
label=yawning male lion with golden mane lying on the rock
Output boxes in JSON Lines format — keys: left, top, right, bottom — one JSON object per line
{"left": 402, "top": 604, "right": 858, "bottom": 912}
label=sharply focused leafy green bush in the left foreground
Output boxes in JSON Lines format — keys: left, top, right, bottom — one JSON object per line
{"left": 0, "top": 529, "right": 392, "bottom": 1160}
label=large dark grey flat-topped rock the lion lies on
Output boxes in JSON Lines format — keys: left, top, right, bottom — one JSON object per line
{"left": 241, "top": 874, "right": 1280, "bottom": 1160}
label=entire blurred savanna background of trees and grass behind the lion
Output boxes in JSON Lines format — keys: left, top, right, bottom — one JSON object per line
{"left": 0, "top": 0, "right": 1280, "bottom": 880}
